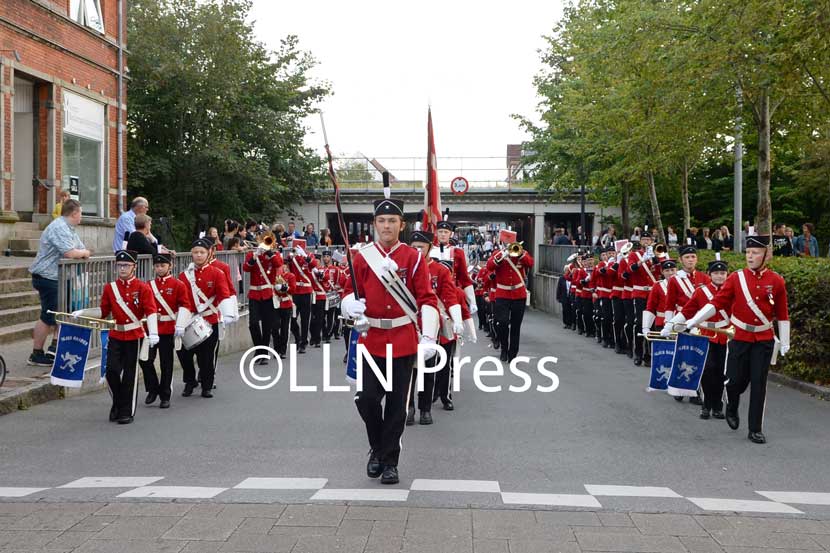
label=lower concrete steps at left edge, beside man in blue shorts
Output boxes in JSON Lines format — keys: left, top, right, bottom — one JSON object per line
{"left": 0, "top": 267, "right": 40, "bottom": 344}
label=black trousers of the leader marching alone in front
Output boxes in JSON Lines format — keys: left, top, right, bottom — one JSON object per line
{"left": 354, "top": 355, "right": 415, "bottom": 466}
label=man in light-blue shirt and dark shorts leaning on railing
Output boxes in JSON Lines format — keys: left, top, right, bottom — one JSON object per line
{"left": 28, "top": 200, "right": 91, "bottom": 367}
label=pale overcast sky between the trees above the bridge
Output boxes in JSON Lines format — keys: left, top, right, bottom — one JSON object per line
{"left": 252, "top": 0, "right": 562, "bottom": 185}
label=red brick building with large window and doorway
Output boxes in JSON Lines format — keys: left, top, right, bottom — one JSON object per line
{"left": 0, "top": 0, "right": 127, "bottom": 251}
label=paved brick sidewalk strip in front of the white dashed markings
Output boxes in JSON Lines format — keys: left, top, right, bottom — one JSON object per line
{"left": 0, "top": 502, "right": 830, "bottom": 553}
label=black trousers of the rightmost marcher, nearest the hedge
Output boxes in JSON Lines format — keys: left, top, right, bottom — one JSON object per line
{"left": 726, "top": 340, "right": 775, "bottom": 432}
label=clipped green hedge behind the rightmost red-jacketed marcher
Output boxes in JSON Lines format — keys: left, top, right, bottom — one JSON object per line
{"left": 698, "top": 250, "right": 830, "bottom": 385}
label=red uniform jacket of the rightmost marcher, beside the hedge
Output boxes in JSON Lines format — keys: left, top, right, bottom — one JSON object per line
{"left": 710, "top": 268, "right": 790, "bottom": 342}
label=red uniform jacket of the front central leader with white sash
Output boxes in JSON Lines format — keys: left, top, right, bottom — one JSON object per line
{"left": 344, "top": 242, "right": 438, "bottom": 358}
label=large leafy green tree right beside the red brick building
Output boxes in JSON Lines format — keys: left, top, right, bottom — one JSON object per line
{"left": 127, "top": 0, "right": 328, "bottom": 247}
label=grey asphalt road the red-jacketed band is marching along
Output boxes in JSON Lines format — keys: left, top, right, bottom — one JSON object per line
{"left": 0, "top": 312, "right": 830, "bottom": 515}
